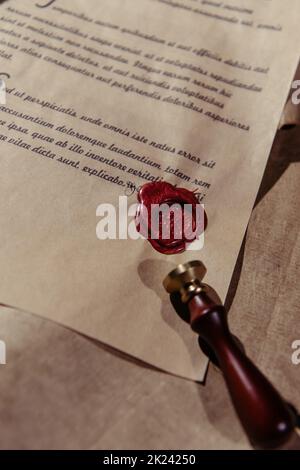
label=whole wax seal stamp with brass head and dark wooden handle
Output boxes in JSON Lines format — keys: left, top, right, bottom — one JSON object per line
{"left": 163, "top": 260, "right": 298, "bottom": 450}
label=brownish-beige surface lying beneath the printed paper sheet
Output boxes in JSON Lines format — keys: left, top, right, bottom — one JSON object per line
{"left": 0, "top": 128, "right": 300, "bottom": 449}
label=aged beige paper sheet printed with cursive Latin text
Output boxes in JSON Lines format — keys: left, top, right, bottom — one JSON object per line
{"left": 0, "top": 0, "right": 300, "bottom": 380}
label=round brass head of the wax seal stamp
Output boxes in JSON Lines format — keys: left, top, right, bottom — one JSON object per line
{"left": 163, "top": 261, "right": 206, "bottom": 303}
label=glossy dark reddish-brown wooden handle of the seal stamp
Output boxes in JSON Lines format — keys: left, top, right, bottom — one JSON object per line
{"left": 188, "top": 293, "right": 296, "bottom": 449}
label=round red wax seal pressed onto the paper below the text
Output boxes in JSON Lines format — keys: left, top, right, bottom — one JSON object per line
{"left": 136, "top": 181, "right": 206, "bottom": 255}
